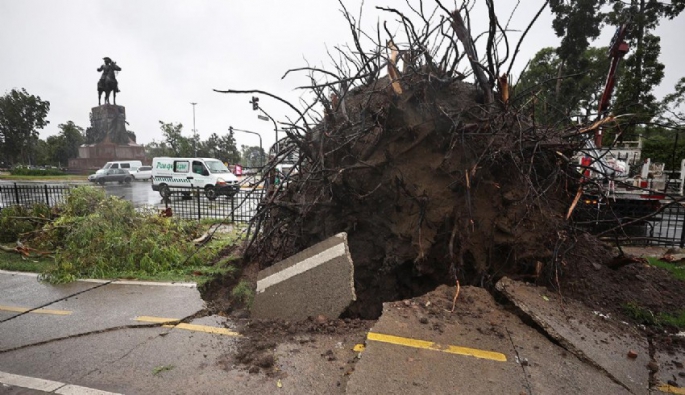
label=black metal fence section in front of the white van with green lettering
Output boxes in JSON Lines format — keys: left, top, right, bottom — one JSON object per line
{"left": 164, "top": 187, "right": 264, "bottom": 222}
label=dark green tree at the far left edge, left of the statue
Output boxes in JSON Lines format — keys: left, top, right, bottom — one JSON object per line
{"left": 0, "top": 88, "right": 50, "bottom": 163}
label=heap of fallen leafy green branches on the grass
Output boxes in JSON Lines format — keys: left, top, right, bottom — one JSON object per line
{"left": 35, "top": 187, "right": 202, "bottom": 283}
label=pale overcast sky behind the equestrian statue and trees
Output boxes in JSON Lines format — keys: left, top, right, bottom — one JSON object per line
{"left": 0, "top": 0, "right": 685, "bottom": 153}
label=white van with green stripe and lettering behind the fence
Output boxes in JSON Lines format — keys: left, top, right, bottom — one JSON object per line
{"left": 152, "top": 157, "right": 240, "bottom": 200}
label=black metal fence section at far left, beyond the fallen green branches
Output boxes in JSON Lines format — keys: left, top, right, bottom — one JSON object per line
{"left": 0, "top": 183, "right": 72, "bottom": 207}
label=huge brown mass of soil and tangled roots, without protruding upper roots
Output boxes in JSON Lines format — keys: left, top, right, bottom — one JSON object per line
{"left": 247, "top": 72, "right": 592, "bottom": 318}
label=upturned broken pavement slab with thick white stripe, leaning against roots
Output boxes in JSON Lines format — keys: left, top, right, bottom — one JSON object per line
{"left": 252, "top": 233, "right": 356, "bottom": 321}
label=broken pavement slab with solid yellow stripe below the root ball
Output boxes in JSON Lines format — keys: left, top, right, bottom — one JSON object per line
{"left": 346, "top": 286, "right": 627, "bottom": 394}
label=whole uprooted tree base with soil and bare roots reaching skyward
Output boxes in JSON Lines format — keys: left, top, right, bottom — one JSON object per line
{"left": 220, "top": 2, "right": 620, "bottom": 317}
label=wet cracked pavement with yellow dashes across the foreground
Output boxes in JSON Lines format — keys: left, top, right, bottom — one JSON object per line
{"left": 5, "top": 272, "right": 682, "bottom": 395}
